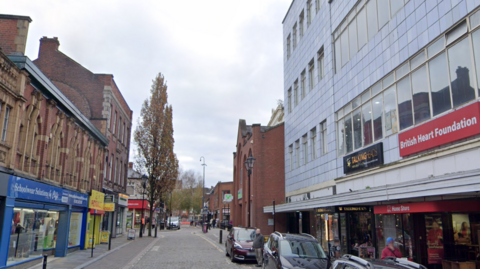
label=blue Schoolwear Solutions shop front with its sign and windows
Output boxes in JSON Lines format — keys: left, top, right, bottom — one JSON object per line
{"left": 0, "top": 175, "right": 88, "bottom": 268}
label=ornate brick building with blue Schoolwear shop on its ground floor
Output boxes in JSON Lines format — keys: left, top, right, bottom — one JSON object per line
{"left": 0, "top": 15, "right": 109, "bottom": 268}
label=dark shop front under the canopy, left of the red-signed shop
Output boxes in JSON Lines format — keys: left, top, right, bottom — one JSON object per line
{"left": 315, "top": 205, "right": 376, "bottom": 258}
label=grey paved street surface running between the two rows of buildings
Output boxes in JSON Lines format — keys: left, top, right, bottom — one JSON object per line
{"left": 25, "top": 226, "right": 255, "bottom": 269}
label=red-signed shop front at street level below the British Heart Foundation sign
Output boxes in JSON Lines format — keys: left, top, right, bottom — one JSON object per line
{"left": 374, "top": 200, "right": 480, "bottom": 268}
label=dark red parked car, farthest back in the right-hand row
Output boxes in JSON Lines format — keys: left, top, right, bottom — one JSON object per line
{"left": 225, "top": 227, "right": 256, "bottom": 262}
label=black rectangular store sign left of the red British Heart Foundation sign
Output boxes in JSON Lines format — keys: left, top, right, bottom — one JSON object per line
{"left": 343, "top": 143, "right": 383, "bottom": 174}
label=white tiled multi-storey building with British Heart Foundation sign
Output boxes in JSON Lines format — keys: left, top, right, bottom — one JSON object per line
{"left": 264, "top": 0, "right": 480, "bottom": 264}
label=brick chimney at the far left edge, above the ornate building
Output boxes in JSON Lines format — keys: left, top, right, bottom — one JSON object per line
{"left": 0, "top": 14, "right": 32, "bottom": 55}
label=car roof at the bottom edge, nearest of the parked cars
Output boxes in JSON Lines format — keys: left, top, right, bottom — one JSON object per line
{"left": 331, "top": 255, "right": 427, "bottom": 269}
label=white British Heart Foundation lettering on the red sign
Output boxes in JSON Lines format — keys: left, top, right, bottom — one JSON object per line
{"left": 400, "top": 117, "right": 478, "bottom": 149}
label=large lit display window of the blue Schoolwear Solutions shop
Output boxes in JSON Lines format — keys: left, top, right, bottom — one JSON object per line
{"left": 7, "top": 208, "right": 58, "bottom": 265}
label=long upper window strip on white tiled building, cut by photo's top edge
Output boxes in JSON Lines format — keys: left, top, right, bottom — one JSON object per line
{"left": 333, "top": 0, "right": 408, "bottom": 71}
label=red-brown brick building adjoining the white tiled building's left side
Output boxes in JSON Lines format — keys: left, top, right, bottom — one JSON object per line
{"left": 231, "top": 120, "right": 286, "bottom": 234}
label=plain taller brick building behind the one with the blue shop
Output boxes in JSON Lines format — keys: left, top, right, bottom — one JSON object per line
{"left": 34, "top": 37, "right": 132, "bottom": 237}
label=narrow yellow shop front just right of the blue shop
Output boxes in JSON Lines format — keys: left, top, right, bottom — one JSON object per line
{"left": 85, "top": 190, "right": 105, "bottom": 248}
